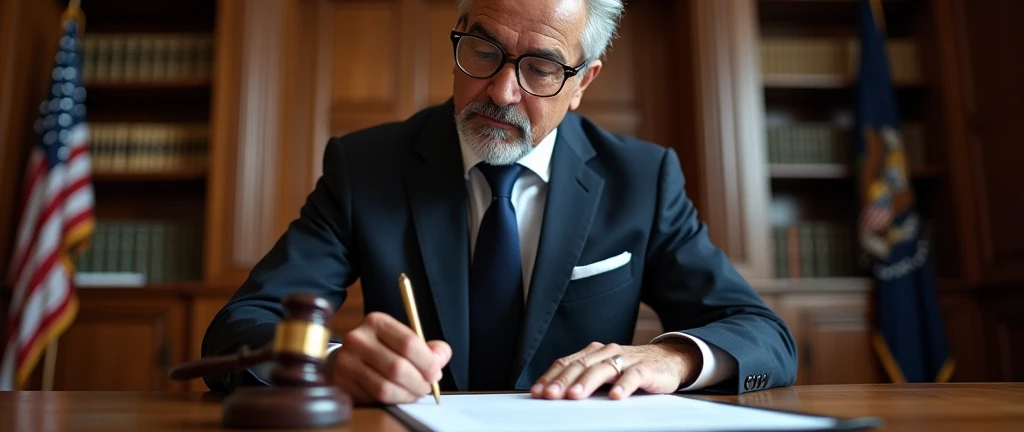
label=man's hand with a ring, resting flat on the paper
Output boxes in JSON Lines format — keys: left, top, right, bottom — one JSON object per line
{"left": 530, "top": 339, "right": 702, "bottom": 399}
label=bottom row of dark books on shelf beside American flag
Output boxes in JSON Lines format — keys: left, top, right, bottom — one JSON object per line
{"left": 76, "top": 219, "right": 203, "bottom": 286}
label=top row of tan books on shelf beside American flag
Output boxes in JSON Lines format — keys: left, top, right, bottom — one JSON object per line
{"left": 82, "top": 33, "right": 213, "bottom": 83}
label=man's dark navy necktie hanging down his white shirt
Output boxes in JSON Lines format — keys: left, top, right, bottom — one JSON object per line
{"left": 469, "top": 164, "right": 523, "bottom": 391}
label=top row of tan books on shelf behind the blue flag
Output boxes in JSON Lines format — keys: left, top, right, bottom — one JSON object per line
{"left": 761, "top": 38, "right": 921, "bottom": 82}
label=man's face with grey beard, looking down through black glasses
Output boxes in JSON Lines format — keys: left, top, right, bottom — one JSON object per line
{"left": 454, "top": 0, "right": 601, "bottom": 165}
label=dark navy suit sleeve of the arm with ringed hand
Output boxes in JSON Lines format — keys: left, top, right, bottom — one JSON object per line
{"left": 642, "top": 149, "right": 797, "bottom": 393}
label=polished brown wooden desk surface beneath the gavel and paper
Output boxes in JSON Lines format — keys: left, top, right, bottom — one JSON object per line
{"left": 0, "top": 383, "right": 1024, "bottom": 432}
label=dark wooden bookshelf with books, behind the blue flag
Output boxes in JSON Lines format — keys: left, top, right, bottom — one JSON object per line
{"left": 758, "top": 0, "right": 958, "bottom": 280}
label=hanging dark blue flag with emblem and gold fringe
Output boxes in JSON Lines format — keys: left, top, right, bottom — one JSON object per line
{"left": 854, "top": 0, "right": 953, "bottom": 383}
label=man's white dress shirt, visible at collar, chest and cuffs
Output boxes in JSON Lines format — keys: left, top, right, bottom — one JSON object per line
{"left": 328, "top": 128, "right": 736, "bottom": 391}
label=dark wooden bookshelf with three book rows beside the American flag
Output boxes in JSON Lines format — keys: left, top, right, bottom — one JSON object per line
{"left": 72, "top": 0, "right": 217, "bottom": 289}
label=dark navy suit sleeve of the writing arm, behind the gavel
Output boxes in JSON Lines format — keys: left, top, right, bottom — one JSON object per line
{"left": 202, "top": 139, "right": 358, "bottom": 392}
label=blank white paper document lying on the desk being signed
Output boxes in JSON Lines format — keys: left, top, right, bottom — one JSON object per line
{"left": 396, "top": 393, "right": 838, "bottom": 432}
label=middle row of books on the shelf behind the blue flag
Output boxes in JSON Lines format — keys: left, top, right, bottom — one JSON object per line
{"left": 767, "top": 123, "right": 928, "bottom": 166}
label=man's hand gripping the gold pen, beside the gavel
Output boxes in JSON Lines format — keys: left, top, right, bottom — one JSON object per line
{"left": 329, "top": 312, "right": 452, "bottom": 403}
